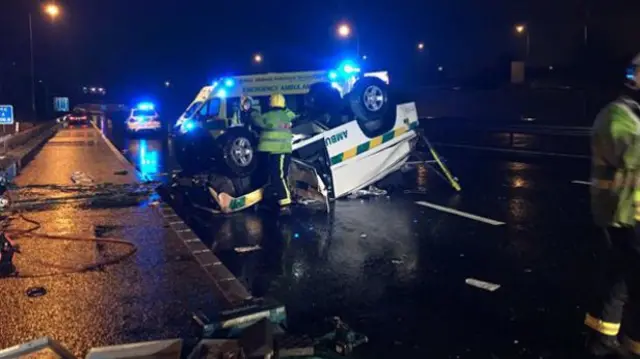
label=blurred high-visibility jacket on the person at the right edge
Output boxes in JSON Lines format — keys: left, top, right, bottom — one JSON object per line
{"left": 591, "top": 97, "right": 640, "bottom": 227}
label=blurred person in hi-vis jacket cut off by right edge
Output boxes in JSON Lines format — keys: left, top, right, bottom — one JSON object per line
{"left": 585, "top": 55, "right": 640, "bottom": 358}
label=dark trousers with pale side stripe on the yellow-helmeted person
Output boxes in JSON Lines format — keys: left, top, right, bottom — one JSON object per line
{"left": 265, "top": 153, "right": 291, "bottom": 207}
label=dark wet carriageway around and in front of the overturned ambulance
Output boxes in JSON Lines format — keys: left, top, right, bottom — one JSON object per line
{"left": 100, "top": 116, "right": 599, "bottom": 358}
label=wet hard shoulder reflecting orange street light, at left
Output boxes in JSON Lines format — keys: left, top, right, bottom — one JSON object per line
{"left": 0, "top": 129, "right": 217, "bottom": 357}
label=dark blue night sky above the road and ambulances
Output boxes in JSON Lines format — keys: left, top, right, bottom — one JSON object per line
{"left": 0, "top": 0, "right": 640, "bottom": 102}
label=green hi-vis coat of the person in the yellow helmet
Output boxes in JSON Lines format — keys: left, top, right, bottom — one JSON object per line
{"left": 251, "top": 108, "right": 296, "bottom": 154}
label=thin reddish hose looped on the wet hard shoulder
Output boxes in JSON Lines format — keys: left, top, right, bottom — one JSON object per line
{"left": 4, "top": 213, "right": 138, "bottom": 279}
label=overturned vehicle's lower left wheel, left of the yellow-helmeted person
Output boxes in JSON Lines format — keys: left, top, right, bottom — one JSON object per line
{"left": 218, "top": 131, "right": 258, "bottom": 177}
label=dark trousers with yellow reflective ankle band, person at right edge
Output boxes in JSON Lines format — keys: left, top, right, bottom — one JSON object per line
{"left": 585, "top": 227, "right": 640, "bottom": 355}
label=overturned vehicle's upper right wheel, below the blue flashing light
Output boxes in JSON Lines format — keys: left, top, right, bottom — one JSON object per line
{"left": 349, "top": 77, "right": 389, "bottom": 122}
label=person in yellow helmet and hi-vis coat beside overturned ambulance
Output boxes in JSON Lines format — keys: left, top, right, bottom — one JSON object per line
{"left": 252, "top": 93, "right": 295, "bottom": 213}
